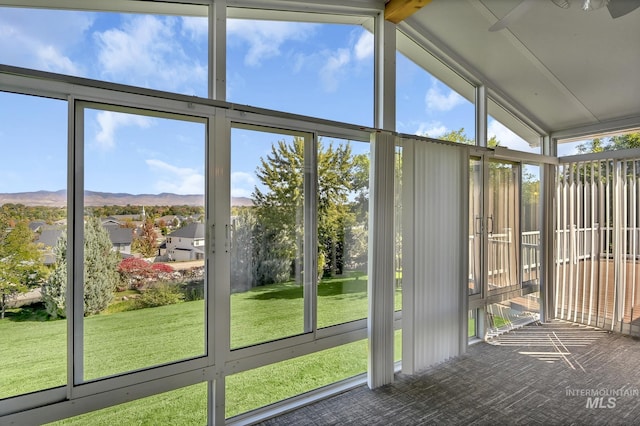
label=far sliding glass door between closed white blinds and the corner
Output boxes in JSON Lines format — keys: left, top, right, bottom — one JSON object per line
{"left": 468, "top": 156, "right": 541, "bottom": 337}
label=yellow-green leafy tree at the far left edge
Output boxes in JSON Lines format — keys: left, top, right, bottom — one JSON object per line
{"left": 0, "top": 222, "right": 46, "bottom": 319}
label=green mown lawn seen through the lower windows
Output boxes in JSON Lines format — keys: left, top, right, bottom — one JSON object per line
{"left": 0, "top": 277, "right": 401, "bottom": 425}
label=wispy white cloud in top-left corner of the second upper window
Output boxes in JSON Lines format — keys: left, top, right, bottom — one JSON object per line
{"left": 227, "top": 19, "right": 315, "bottom": 66}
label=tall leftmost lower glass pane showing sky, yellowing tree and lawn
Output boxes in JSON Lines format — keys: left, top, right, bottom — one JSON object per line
{"left": 0, "top": 92, "right": 67, "bottom": 399}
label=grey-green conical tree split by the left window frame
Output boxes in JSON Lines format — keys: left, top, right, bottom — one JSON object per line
{"left": 43, "top": 217, "right": 120, "bottom": 317}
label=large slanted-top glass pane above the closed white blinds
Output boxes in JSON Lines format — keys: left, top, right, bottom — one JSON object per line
{"left": 396, "top": 44, "right": 475, "bottom": 145}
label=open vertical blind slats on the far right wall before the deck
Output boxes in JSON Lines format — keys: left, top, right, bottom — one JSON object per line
{"left": 554, "top": 159, "right": 640, "bottom": 335}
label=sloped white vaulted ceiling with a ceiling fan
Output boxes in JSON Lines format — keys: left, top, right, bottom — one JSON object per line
{"left": 400, "top": 0, "right": 640, "bottom": 136}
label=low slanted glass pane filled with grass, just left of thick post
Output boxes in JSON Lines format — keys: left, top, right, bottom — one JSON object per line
{"left": 226, "top": 340, "right": 367, "bottom": 418}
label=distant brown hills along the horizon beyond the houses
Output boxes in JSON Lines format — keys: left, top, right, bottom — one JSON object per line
{"left": 0, "top": 190, "right": 253, "bottom": 207}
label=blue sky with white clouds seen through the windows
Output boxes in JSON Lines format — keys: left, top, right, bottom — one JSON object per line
{"left": 0, "top": 8, "right": 536, "bottom": 195}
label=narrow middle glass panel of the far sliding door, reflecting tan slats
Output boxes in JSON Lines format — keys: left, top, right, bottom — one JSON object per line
{"left": 486, "top": 161, "right": 520, "bottom": 291}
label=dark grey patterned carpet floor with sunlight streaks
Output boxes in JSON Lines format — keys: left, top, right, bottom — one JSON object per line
{"left": 262, "top": 322, "right": 640, "bottom": 425}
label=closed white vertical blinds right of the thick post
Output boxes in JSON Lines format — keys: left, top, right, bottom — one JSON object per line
{"left": 402, "top": 139, "right": 469, "bottom": 374}
